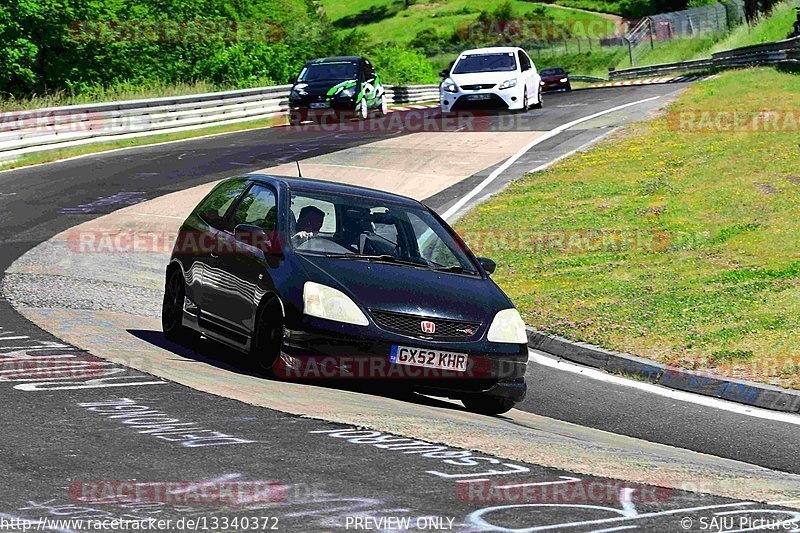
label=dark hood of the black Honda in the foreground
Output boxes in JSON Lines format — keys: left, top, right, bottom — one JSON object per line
{"left": 298, "top": 255, "right": 513, "bottom": 323}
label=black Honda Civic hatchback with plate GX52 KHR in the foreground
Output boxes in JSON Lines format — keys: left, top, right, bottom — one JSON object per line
{"left": 162, "top": 174, "right": 528, "bottom": 414}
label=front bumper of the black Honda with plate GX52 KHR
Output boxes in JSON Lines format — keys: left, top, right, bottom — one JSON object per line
{"left": 279, "top": 317, "right": 528, "bottom": 402}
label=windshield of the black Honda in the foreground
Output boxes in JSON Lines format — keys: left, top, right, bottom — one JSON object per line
{"left": 289, "top": 191, "right": 478, "bottom": 274}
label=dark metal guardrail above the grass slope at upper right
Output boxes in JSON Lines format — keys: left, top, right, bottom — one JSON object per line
{"left": 609, "top": 37, "right": 800, "bottom": 80}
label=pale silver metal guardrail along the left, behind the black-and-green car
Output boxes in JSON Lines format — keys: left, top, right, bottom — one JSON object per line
{"left": 0, "top": 85, "right": 439, "bottom": 160}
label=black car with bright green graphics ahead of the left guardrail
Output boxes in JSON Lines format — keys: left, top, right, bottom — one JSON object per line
{"left": 289, "top": 56, "right": 387, "bottom": 125}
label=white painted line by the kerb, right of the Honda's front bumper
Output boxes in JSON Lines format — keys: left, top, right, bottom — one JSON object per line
{"left": 528, "top": 350, "right": 800, "bottom": 426}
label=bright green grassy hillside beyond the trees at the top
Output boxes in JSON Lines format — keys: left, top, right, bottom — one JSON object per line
{"left": 321, "top": 0, "right": 611, "bottom": 44}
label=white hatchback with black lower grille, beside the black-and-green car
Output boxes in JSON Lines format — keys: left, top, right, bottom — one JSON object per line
{"left": 439, "top": 46, "right": 542, "bottom": 113}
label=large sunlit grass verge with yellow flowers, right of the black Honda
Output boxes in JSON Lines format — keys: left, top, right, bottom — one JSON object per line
{"left": 458, "top": 68, "right": 800, "bottom": 388}
